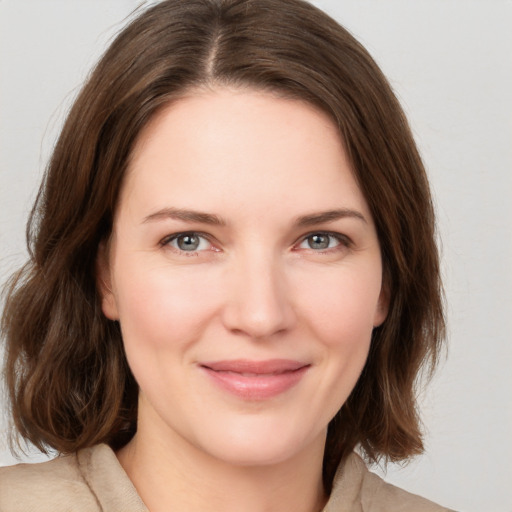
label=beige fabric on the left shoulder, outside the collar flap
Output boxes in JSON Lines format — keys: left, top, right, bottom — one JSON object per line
{"left": 0, "top": 455, "right": 98, "bottom": 512}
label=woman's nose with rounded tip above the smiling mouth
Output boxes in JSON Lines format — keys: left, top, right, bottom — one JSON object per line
{"left": 222, "top": 251, "right": 296, "bottom": 340}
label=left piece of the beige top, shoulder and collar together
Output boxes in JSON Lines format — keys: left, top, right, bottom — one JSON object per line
{"left": 0, "top": 444, "right": 147, "bottom": 512}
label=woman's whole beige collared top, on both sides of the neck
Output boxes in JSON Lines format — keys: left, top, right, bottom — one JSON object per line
{"left": 0, "top": 444, "right": 456, "bottom": 512}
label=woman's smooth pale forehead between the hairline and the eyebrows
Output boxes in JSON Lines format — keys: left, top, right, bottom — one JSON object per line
{"left": 118, "top": 88, "right": 366, "bottom": 223}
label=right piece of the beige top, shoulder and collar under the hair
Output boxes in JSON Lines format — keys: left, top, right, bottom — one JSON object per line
{"left": 324, "top": 453, "right": 456, "bottom": 512}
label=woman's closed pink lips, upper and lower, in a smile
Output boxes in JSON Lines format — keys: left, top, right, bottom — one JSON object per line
{"left": 199, "top": 359, "right": 310, "bottom": 400}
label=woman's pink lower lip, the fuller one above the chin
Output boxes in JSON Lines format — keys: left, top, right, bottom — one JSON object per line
{"left": 202, "top": 366, "right": 309, "bottom": 400}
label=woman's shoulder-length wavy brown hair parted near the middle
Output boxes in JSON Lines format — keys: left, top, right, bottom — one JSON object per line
{"left": 2, "top": 0, "right": 444, "bottom": 492}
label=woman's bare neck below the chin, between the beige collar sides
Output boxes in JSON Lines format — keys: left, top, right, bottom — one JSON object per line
{"left": 117, "top": 412, "right": 326, "bottom": 512}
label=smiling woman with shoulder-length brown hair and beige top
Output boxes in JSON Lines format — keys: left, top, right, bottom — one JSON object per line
{"left": 0, "top": 0, "right": 450, "bottom": 512}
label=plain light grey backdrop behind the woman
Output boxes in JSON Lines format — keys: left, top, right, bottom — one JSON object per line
{"left": 0, "top": 0, "right": 512, "bottom": 512}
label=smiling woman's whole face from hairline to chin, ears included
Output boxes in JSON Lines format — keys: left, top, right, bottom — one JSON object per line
{"left": 100, "top": 88, "right": 386, "bottom": 465}
